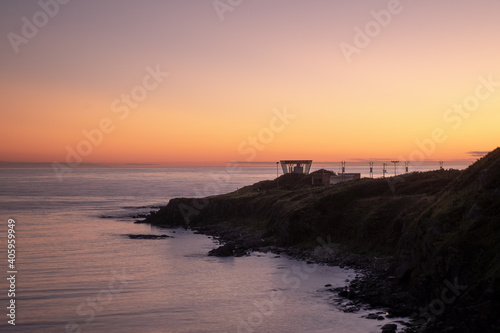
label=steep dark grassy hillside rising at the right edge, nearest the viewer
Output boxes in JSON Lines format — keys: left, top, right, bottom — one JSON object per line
{"left": 400, "top": 148, "right": 500, "bottom": 288}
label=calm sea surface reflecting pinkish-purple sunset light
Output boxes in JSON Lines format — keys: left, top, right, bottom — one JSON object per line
{"left": 0, "top": 165, "right": 463, "bottom": 333}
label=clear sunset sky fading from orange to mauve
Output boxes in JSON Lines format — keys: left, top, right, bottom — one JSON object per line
{"left": 0, "top": 0, "right": 500, "bottom": 166}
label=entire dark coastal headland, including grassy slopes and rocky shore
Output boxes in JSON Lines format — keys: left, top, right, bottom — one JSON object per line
{"left": 144, "top": 148, "right": 500, "bottom": 332}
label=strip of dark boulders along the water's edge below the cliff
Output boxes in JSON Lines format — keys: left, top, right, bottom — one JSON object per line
{"left": 149, "top": 220, "right": 420, "bottom": 333}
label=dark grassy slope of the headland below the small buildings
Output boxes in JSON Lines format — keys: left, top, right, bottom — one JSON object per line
{"left": 216, "top": 166, "right": 460, "bottom": 255}
